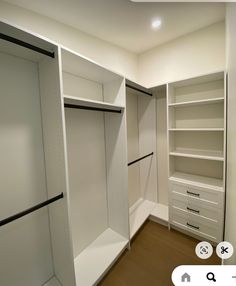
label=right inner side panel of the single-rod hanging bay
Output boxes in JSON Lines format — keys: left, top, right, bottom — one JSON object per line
{"left": 104, "top": 78, "right": 129, "bottom": 239}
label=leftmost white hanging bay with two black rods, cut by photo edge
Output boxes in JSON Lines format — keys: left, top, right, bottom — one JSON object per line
{"left": 0, "top": 23, "right": 74, "bottom": 286}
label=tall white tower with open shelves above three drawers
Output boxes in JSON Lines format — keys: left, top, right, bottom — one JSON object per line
{"left": 168, "top": 72, "right": 226, "bottom": 242}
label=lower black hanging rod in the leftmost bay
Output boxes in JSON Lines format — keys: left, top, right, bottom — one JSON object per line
{"left": 0, "top": 193, "right": 64, "bottom": 226}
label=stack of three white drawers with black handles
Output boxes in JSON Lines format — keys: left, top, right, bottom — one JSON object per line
{"left": 169, "top": 181, "right": 224, "bottom": 242}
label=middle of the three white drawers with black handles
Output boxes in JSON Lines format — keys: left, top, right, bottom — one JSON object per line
{"left": 170, "top": 192, "right": 223, "bottom": 223}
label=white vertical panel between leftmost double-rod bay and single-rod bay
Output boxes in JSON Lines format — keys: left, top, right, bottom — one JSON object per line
{"left": 39, "top": 47, "right": 75, "bottom": 286}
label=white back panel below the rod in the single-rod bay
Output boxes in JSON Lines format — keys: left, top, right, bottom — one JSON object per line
{"left": 65, "top": 108, "right": 108, "bottom": 257}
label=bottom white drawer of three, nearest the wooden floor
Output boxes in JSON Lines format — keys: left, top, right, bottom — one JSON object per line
{"left": 170, "top": 207, "right": 223, "bottom": 241}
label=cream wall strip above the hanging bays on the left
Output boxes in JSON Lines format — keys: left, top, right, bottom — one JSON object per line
{"left": 0, "top": 1, "right": 137, "bottom": 81}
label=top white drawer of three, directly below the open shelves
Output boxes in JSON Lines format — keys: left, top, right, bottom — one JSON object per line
{"left": 170, "top": 182, "right": 224, "bottom": 208}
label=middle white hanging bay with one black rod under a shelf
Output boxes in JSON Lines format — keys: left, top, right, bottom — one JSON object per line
{"left": 61, "top": 49, "right": 129, "bottom": 286}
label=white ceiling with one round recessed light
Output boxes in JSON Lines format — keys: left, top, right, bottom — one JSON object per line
{"left": 5, "top": 0, "right": 225, "bottom": 53}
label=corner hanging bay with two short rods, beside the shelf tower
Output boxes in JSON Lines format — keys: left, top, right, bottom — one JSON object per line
{"left": 126, "top": 80, "right": 168, "bottom": 238}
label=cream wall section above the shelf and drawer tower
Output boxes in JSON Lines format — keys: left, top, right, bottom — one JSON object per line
{"left": 138, "top": 22, "right": 225, "bottom": 87}
